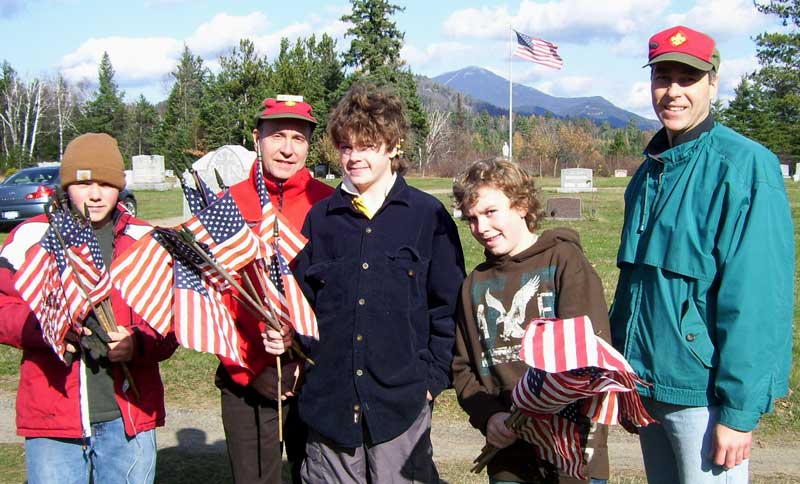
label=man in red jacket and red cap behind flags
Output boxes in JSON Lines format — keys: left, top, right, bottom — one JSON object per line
{"left": 216, "top": 96, "right": 333, "bottom": 484}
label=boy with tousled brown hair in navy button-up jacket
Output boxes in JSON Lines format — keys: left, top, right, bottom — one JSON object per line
{"left": 266, "top": 84, "right": 464, "bottom": 483}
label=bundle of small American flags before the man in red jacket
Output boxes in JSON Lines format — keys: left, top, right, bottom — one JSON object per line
{"left": 111, "top": 169, "right": 318, "bottom": 365}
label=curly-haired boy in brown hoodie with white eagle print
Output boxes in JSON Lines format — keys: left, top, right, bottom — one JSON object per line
{"left": 453, "top": 160, "right": 610, "bottom": 484}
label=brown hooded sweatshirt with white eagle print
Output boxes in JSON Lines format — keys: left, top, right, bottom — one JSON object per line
{"left": 453, "top": 228, "right": 611, "bottom": 483}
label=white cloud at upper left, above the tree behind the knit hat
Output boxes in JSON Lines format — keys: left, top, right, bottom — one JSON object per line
{"left": 60, "top": 37, "right": 183, "bottom": 85}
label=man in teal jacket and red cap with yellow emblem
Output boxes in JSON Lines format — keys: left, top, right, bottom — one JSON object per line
{"left": 611, "top": 26, "right": 794, "bottom": 484}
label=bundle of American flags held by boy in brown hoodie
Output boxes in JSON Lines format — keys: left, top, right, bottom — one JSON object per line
{"left": 511, "top": 316, "right": 654, "bottom": 478}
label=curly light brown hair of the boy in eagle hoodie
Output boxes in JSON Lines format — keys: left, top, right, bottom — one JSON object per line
{"left": 453, "top": 158, "right": 543, "bottom": 232}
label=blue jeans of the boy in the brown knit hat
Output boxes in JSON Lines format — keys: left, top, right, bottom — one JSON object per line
{"left": 25, "top": 418, "right": 156, "bottom": 484}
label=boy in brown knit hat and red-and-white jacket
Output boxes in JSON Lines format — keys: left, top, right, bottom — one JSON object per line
{"left": 0, "top": 133, "right": 177, "bottom": 484}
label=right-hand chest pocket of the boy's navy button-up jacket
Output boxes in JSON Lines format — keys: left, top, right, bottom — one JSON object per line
{"left": 383, "top": 246, "right": 430, "bottom": 312}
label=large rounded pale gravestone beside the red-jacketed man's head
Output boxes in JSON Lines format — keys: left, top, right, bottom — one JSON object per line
{"left": 183, "top": 145, "right": 256, "bottom": 218}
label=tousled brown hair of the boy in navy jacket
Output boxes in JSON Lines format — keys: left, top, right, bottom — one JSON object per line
{"left": 328, "top": 82, "right": 408, "bottom": 174}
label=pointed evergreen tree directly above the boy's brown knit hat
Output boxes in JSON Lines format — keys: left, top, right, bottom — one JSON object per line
{"left": 77, "top": 52, "right": 125, "bottom": 139}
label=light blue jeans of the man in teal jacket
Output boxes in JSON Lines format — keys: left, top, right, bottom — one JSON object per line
{"left": 639, "top": 398, "right": 749, "bottom": 484}
